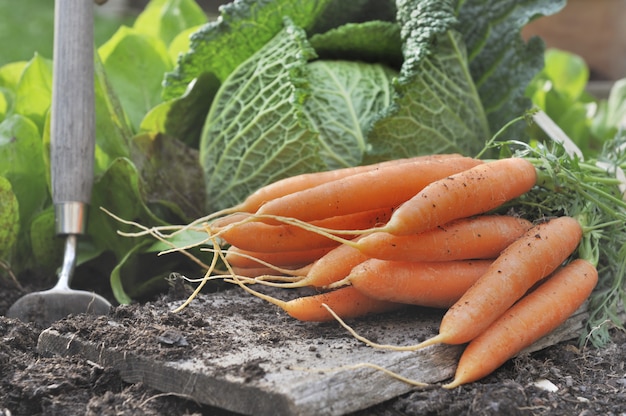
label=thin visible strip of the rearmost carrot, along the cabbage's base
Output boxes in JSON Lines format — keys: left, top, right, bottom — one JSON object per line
{"left": 226, "top": 154, "right": 462, "bottom": 213}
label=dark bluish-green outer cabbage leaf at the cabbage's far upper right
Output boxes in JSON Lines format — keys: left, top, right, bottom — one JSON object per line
{"left": 458, "top": 0, "right": 566, "bottom": 132}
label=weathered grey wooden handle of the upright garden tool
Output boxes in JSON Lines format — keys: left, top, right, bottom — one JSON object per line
{"left": 50, "top": 0, "right": 95, "bottom": 204}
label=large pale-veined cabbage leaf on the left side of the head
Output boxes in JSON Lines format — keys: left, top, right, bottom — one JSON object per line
{"left": 200, "top": 23, "right": 325, "bottom": 210}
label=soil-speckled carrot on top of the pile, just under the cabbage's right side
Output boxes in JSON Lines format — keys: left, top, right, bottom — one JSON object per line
{"left": 376, "top": 158, "right": 537, "bottom": 235}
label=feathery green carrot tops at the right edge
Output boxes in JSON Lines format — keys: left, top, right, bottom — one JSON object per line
{"left": 488, "top": 132, "right": 626, "bottom": 345}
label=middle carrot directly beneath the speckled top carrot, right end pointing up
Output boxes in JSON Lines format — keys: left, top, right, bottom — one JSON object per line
{"left": 354, "top": 215, "right": 532, "bottom": 261}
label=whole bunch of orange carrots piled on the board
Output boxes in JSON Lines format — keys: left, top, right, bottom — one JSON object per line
{"left": 174, "top": 155, "right": 598, "bottom": 387}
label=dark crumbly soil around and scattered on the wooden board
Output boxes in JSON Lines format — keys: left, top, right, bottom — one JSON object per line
{"left": 0, "top": 274, "right": 626, "bottom": 416}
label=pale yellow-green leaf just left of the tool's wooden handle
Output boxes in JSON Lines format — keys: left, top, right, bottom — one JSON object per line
{"left": 14, "top": 54, "right": 52, "bottom": 131}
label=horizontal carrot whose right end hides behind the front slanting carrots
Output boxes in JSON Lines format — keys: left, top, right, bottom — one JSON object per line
{"left": 346, "top": 259, "right": 492, "bottom": 308}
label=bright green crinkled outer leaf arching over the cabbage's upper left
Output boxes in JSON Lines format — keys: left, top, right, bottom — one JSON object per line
{"left": 163, "top": 0, "right": 332, "bottom": 100}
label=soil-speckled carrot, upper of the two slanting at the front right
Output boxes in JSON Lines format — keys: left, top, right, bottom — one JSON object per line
{"left": 416, "top": 217, "right": 582, "bottom": 349}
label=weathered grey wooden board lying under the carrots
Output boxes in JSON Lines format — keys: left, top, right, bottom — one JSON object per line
{"left": 38, "top": 290, "right": 586, "bottom": 416}
